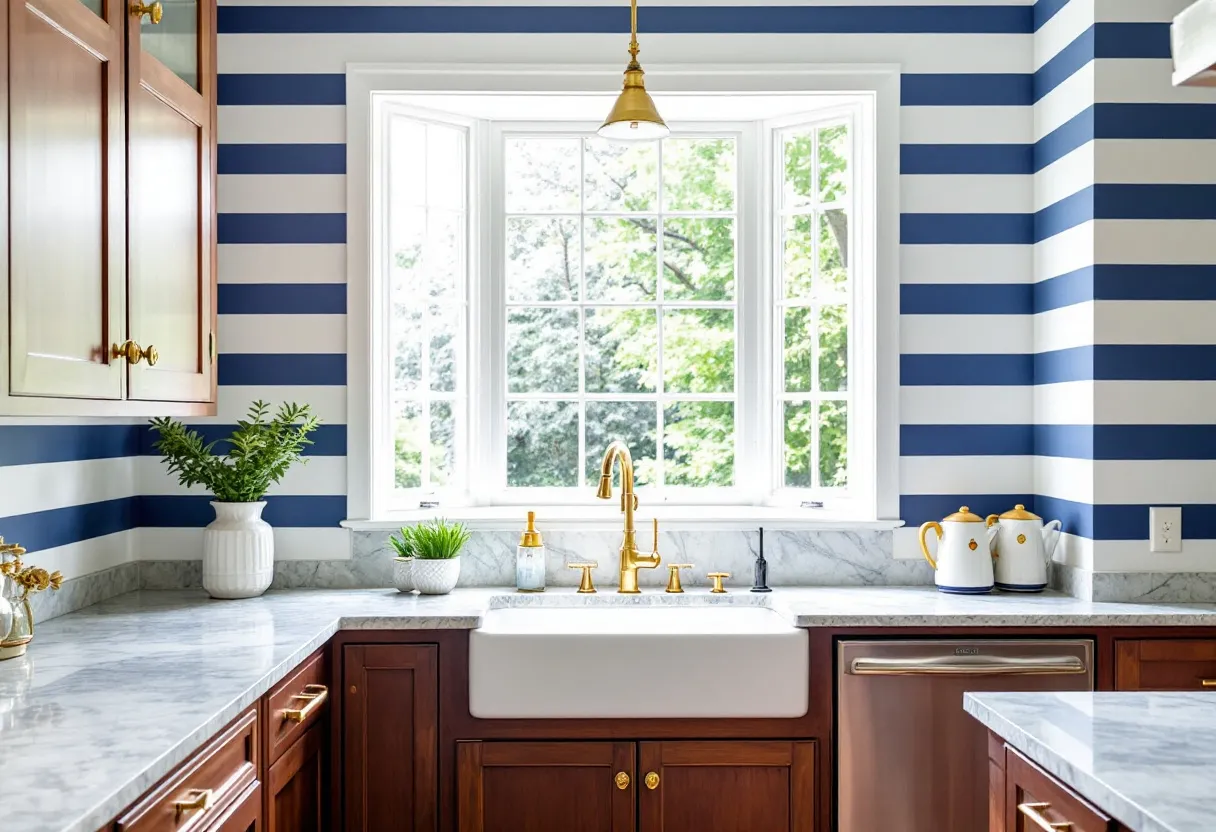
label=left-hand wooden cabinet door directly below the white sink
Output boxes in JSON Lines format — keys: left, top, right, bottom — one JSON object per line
{"left": 456, "top": 742, "right": 637, "bottom": 832}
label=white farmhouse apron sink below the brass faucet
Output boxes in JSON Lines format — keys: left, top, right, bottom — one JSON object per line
{"left": 468, "top": 606, "right": 809, "bottom": 719}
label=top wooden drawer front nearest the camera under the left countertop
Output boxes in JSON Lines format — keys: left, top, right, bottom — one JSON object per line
{"left": 114, "top": 708, "right": 260, "bottom": 832}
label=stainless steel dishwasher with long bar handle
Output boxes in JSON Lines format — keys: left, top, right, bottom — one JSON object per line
{"left": 837, "top": 639, "right": 1093, "bottom": 832}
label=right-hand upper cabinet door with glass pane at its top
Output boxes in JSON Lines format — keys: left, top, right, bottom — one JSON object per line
{"left": 127, "top": 0, "right": 215, "bottom": 401}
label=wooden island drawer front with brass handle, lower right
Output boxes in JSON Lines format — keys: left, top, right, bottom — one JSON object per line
{"left": 1004, "top": 746, "right": 1118, "bottom": 832}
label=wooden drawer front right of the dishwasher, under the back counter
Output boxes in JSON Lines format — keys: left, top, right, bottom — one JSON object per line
{"left": 1115, "top": 639, "right": 1216, "bottom": 691}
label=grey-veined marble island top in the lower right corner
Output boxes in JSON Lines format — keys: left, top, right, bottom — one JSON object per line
{"left": 963, "top": 691, "right": 1216, "bottom": 832}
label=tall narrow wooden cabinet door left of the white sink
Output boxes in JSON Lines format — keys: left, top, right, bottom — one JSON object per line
{"left": 342, "top": 645, "right": 439, "bottom": 832}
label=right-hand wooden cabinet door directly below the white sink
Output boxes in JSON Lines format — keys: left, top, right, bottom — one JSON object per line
{"left": 637, "top": 741, "right": 815, "bottom": 832}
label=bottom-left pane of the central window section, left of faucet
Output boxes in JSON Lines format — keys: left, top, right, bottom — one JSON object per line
{"left": 507, "top": 401, "right": 579, "bottom": 488}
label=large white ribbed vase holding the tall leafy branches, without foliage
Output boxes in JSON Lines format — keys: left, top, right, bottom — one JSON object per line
{"left": 203, "top": 501, "right": 275, "bottom": 598}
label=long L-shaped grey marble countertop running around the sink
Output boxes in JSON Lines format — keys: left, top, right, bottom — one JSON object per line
{"left": 7, "top": 588, "right": 1216, "bottom": 832}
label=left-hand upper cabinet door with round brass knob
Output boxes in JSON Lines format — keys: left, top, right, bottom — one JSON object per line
{"left": 9, "top": 0, "right": 126, "bottom": 399}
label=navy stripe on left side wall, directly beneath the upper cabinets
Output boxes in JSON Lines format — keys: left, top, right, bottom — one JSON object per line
{"left": 0, "top": 425, "right": 140, "bottom": 467}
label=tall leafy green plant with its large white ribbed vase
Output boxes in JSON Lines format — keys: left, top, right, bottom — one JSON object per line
{"left": 152, "top": 401, "right": 320, "bottom": 598}
